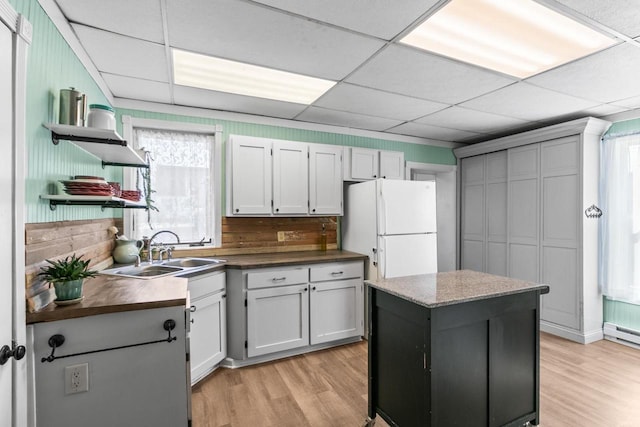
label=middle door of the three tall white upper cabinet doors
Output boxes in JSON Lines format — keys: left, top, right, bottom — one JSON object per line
{"left": 273, "top": 141, "right": 309, "bottom": 215}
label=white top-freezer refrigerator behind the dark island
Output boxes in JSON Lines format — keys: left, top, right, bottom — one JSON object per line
{"left": 342, "top": 179, "right": 438, "bottom": 279}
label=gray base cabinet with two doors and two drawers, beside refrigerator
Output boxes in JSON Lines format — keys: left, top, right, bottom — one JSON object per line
{"left": 224, "top": 261, "right": 364, "bottom": 366}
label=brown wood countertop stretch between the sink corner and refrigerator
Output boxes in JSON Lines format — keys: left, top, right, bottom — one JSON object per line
{"left": 221, "top": 250, "right": 367, "bottom": 269}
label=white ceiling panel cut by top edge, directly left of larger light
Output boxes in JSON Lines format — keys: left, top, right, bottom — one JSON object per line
{"left": 250, "top": 0, "right": 438, "bottom": 40}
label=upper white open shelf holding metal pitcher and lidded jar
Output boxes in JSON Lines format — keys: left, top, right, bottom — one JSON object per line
{"left": 44, "top": 123, "right": 149, "bottom": 168}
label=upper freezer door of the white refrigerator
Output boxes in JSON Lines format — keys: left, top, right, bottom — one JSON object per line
{"left": 377, "top": 179, "right": 437, "bottom": 235}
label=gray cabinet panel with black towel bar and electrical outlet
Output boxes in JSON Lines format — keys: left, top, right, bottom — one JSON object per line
{"left": 27, "top": 306, "right": 191, "bottom": 427}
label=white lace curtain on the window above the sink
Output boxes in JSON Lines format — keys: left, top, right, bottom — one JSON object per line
{"left": 133, "top": 128, "right": 214, "bottom": 242}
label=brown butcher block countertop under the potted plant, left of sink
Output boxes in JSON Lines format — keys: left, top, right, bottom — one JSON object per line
{"left": 27, "top": 275, "right": 188, "bottom": 324}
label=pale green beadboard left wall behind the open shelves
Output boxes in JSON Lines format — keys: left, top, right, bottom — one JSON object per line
{"left": 10, "top": 0, "right": 117, "bottom": 223}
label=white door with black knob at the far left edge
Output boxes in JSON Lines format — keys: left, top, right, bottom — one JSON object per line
{"left": 0, "top": 21, "right": 13, "bottom": 426}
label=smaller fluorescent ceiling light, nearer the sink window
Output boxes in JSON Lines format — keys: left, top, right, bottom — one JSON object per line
{"left": 173, "top": 49, "right": 336, "bottom": 104}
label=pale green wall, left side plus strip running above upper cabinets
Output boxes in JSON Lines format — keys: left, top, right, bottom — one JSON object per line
{"left": 9, "top": 0, "right": 456, "bottom": 223}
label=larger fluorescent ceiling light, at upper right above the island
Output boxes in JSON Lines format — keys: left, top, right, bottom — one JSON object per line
{"left": 400, "top": 0, "right": 616, "bottom": 78}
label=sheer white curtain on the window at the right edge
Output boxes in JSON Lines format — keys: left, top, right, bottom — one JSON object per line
{"left": 599, "top": 134, "right": 640, "bottom": 304}
